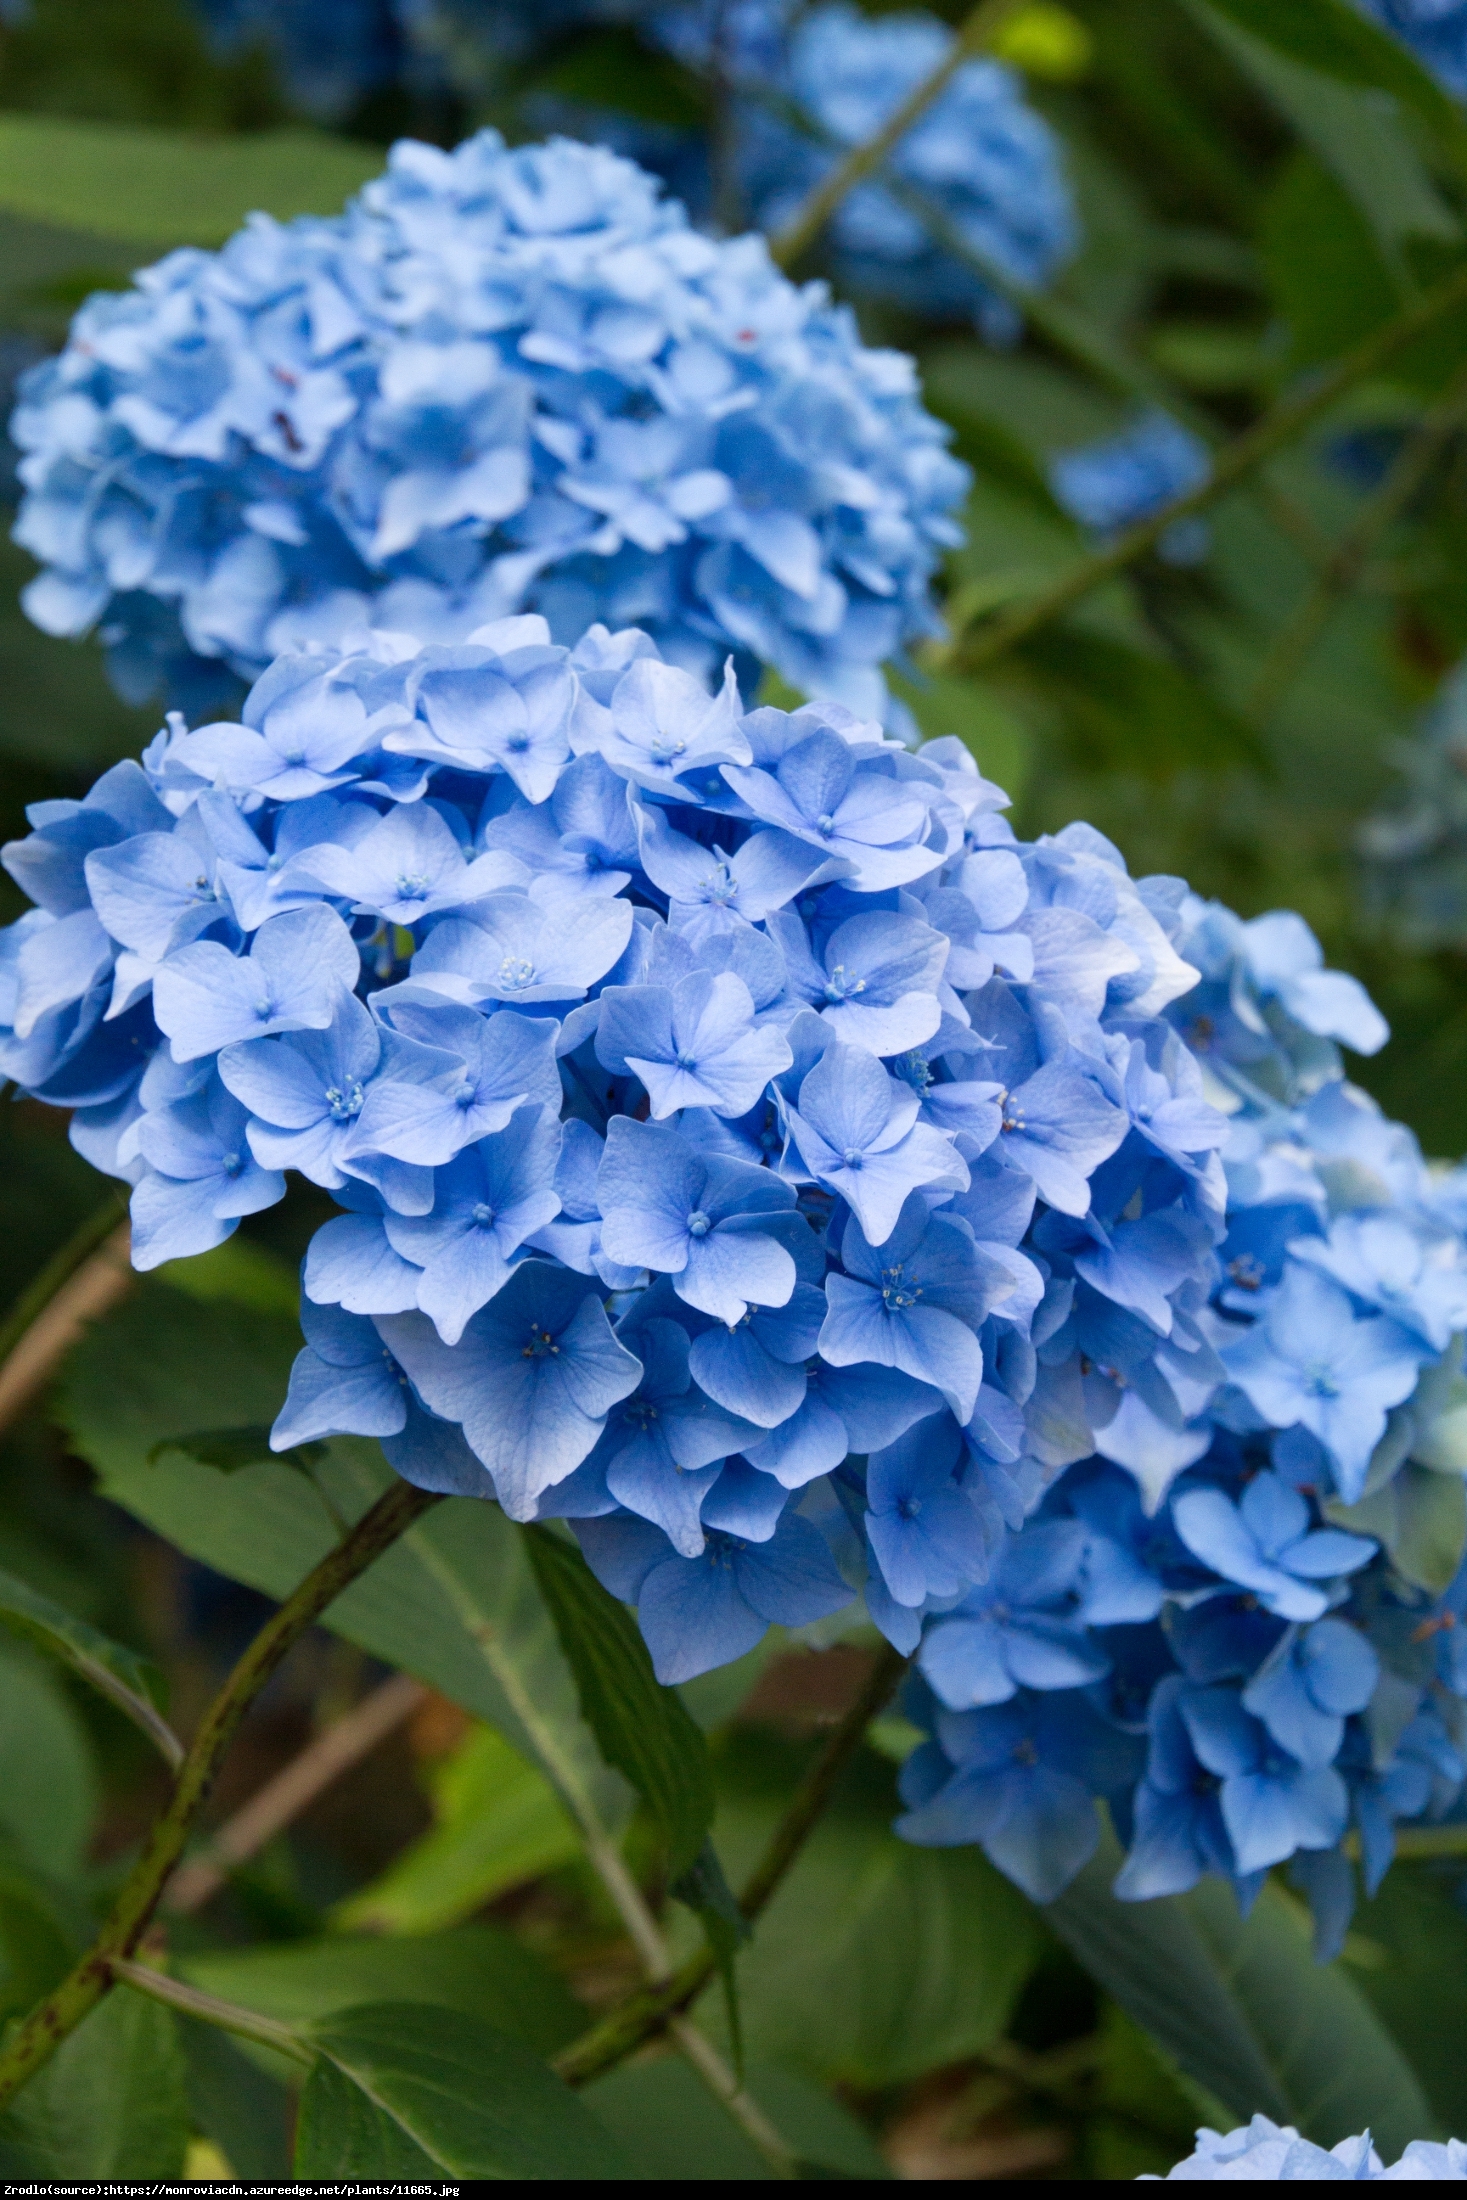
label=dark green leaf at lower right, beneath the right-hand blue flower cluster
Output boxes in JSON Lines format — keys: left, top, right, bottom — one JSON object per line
{"left": 1043, "top": 1837, "right": 1430, "bottom": 2158}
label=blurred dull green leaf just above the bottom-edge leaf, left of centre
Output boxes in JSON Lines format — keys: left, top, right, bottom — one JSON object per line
{"left": 186, "top": 1925, "right": 585, "bottom": 2055}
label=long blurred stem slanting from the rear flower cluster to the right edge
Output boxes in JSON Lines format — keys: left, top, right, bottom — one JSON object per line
{"left": 944, "top": 266, "right": 1467, "bottom": 671}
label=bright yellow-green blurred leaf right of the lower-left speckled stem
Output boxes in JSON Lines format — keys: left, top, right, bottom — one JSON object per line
{"left": 332, "top": 1727, "right": 581, "bottom": 1934}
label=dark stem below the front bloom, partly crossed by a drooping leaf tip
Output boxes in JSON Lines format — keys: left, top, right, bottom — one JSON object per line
{"left": 556, "top": 1646, "right": 911, "bottom": 2086}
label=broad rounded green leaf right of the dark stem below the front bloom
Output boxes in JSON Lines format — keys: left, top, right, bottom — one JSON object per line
{"left": 708, "top": 1734, "right": 1045, "bottom": 2088}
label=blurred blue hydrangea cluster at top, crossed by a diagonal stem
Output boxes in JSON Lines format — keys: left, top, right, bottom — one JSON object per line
{"left": 739, "top": 0, "right": 1078, "bottom": 343}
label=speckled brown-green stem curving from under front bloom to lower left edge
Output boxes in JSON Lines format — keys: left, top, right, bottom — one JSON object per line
{"left": 0, "top": 1483, "right": 440, "bottom": 2108}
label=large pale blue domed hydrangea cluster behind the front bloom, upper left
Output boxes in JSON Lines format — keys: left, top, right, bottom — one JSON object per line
{"left": 13, "top": 130, "right": 966, "bottom": 717}
